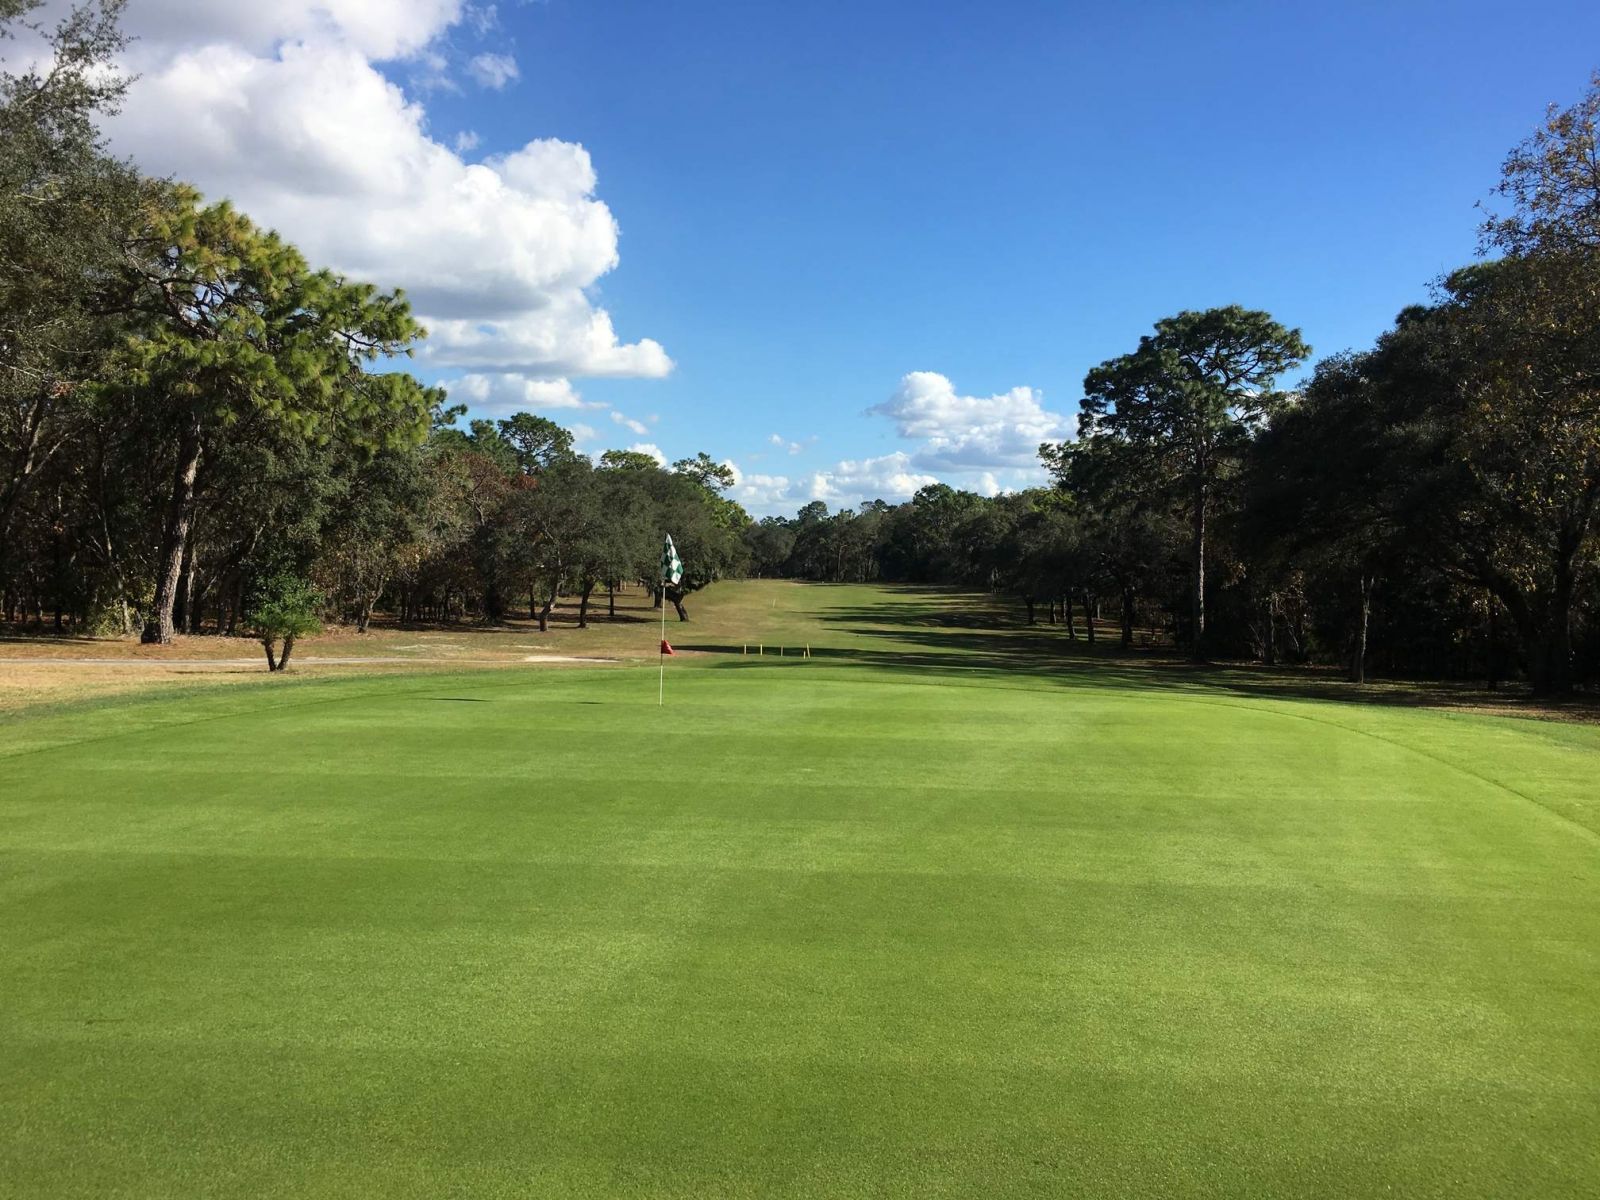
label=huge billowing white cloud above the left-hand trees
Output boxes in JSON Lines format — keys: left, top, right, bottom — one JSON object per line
{"left": 109, "top": 0, "right": 672, "bottom": 390}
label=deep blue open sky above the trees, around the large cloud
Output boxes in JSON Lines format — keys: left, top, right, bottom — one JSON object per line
{"left": 93, "top": 0, "right": 1600, "bottom": 510}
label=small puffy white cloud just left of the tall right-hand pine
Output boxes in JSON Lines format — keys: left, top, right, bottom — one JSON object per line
{"left": 870, "top": 371, "right": 1070, "bottom": 472}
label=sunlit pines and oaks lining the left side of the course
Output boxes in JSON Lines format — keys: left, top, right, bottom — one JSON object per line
{"left": 0, "top": 0, "right": 749, "bottom": 659}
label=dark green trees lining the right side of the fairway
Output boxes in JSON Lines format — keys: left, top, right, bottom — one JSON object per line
{"left": 749, "top": 77, "right": 1600, "bottom": 694}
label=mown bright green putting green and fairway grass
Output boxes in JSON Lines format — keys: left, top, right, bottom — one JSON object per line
{"left": 0, "top": 584, "right": 1600, "bottom": 1197}
